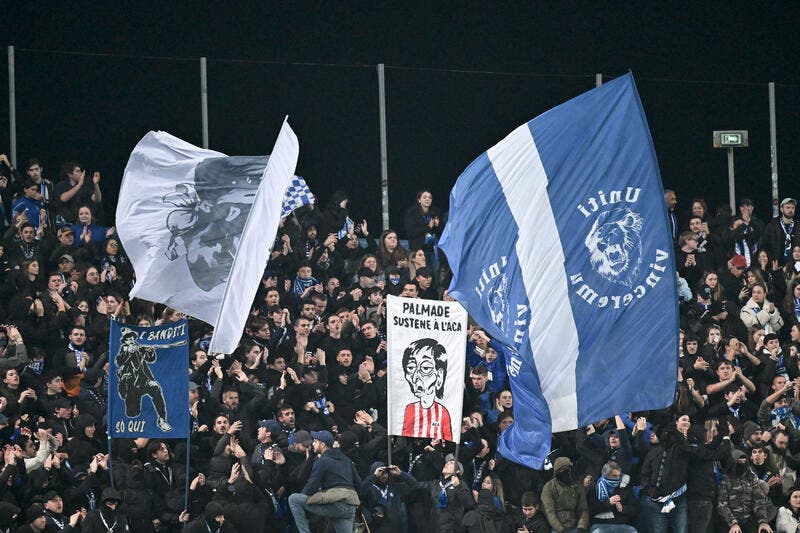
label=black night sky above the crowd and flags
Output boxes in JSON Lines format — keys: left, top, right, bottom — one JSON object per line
{"left": 0, "top": 2, "right": 800, "bottom": 230}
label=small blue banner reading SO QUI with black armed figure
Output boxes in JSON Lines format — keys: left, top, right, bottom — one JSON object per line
{"left": 108, "top": 319, "right": 189, "bottom": 439}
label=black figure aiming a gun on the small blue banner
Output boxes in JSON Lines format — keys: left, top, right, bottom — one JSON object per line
{"left": 114, "top": 328, "right": 179, "bottom": 432}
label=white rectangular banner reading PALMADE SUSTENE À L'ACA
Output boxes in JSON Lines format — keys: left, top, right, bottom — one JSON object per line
{"left": 386, "top": 295, "right": 467, "bottom": 443}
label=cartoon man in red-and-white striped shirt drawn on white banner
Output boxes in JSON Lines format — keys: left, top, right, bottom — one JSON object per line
{"left": 403, "top": 339, "right": 452, "bottom": 440}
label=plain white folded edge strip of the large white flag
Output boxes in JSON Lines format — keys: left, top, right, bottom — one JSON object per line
{"left": 209, "top": 117, "right": 300, "bottom": 354}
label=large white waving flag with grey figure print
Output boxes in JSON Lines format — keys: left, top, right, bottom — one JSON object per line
{"left": 117, "top": 121, "right": 299, "bottom": 354}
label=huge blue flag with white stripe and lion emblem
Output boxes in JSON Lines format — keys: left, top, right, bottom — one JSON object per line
{"left": 440, "top": 74, "right": 678, "bottom": 468}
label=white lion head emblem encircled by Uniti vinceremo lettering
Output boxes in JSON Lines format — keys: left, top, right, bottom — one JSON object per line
{"left": 584, "top": 207, "right": 644, "bottom": 287}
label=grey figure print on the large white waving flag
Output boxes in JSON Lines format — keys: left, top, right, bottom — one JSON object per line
{"left": 164, "top": 156, "right": 269, "bottom": 292}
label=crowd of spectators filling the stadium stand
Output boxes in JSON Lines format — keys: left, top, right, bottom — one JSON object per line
{"left": 0, "top": 151, "right": 800, "bottom": 533}
